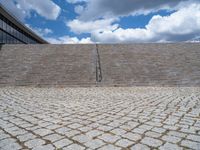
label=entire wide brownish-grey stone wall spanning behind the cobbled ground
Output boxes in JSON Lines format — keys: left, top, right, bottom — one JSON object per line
{"left": 0, "top": 43, "right": 200, "bottom": 87}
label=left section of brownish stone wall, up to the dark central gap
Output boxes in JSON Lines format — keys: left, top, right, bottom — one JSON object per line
{"left": 0, "top": 45, "right": 96, "bottom": 86}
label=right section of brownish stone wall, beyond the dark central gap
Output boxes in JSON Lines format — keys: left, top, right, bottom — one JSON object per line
{"left": 99, "top": 44, "right": 200, "bottom": 86}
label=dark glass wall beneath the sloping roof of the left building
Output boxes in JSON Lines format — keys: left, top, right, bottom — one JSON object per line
{"left": 0, "top": 14, "right": 38, "bottom": 44}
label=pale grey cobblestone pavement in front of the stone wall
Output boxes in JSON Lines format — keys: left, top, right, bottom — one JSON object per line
{"left": 0, "top": 87, "right": 200, "bottom": 150}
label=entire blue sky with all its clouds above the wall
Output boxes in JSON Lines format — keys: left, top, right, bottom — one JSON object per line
{"left": 0, "top": 0, "right": 200, "bottom": 44}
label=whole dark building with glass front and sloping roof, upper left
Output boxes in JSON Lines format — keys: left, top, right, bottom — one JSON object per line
{"left": 0, "top": 4, "right": 48, "bottom": 44}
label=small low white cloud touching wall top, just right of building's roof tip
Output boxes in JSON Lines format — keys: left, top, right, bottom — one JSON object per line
{"left": 46, "top": 36, "right": 93, "bottom": 44}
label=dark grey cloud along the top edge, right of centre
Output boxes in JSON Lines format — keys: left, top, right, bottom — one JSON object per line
{"left": 79, "top": 0, "right": 195, "bottom": 20}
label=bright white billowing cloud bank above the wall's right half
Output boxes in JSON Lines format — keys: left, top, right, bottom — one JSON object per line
{"left": 92, "top": 4, "right": 200, "bottom": 43}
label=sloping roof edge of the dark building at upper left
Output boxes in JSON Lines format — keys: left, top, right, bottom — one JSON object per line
{"left": 0, "top": 3, "right": 49, "bottom": 44}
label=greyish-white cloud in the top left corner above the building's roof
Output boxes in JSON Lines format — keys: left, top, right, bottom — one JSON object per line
{"left": 0, "top": 0, "right": 61, "bottom": 20}
